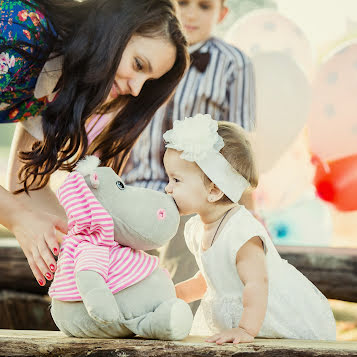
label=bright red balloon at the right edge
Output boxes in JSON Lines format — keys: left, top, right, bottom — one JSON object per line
{"left": 312, "top": 154, "right": 357, "bottom": 211}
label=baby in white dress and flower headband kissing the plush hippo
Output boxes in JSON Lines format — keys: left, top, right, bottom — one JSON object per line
{"left": 164, "top": 114, "right": 336, "bottom": 344}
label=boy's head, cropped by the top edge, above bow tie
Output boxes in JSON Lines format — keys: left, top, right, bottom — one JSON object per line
{"left": 178, "top": 0, "right": 228, "bottom": 45}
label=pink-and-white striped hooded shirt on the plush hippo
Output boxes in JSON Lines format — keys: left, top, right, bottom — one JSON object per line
{"left": 49, "top": 172, "right": 158, "bottom": 301}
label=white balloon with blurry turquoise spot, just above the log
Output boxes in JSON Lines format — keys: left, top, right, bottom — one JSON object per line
{"left": 262, "top": 194, "right": 333, "bottom": 246}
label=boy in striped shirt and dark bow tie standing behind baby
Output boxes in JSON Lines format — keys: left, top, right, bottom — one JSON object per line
{"left": 122, "top": 0, "right": 255, "bottom": 300}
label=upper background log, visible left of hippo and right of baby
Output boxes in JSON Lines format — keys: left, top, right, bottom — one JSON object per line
{"left": 0, "top": 239, "right": 357, "bottom": 302}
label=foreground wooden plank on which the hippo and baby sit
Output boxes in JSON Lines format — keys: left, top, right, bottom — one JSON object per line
{"left": 0, "top": 330, "right": 357, "bottom": 357}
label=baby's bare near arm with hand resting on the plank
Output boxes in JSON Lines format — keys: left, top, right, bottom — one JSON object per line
{"left": 207, "top": 237, "right": 268, "bottom": 344}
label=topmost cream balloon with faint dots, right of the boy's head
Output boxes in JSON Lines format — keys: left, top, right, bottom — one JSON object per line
{"left": 225, "top": 9, "right": 314, "bottom": 78}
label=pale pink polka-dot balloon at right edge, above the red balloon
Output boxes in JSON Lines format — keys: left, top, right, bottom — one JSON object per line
{"left": 308, "top": 42, "right": 357, "bottom": 161}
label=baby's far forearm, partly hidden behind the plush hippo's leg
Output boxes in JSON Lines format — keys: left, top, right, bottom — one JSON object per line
{"left": 175, "top": 272, "right": 207, "bottom": 303}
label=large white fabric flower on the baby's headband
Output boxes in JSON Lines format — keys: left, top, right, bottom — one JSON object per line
{"left": 164, "top": 114, "right": 224, "bottom": 161}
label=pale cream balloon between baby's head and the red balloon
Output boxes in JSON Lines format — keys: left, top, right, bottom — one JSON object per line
{"left": 253, "top": 129, "right": 315, "bottom": 212}
